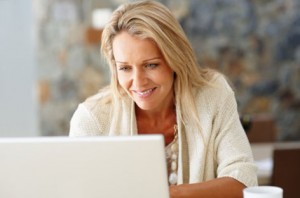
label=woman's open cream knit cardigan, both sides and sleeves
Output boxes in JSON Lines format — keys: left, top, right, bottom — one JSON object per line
{"left": 69, "top": 75, "right": 257, "bottom": 186}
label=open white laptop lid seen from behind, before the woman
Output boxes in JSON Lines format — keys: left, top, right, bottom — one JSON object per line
{"left": 0, "top": 135, "right": 169, "bottom": 198}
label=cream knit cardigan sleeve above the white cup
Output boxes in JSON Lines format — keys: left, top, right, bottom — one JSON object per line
{"left": 215, "top": 85, "right": 257, "bottom": 186}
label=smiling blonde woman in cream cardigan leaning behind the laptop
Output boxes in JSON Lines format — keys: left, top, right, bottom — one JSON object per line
{"left": 70, "top": 1, "right": 257, "bottom": 198}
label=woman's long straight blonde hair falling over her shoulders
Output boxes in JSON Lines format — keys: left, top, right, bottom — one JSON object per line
{"left": 101, "top": 1, "right": 216, "bottom": 132}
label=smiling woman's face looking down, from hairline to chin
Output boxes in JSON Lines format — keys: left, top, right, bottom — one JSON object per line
{"left": 113, "top": 31, "right": 174, "bottom": 112}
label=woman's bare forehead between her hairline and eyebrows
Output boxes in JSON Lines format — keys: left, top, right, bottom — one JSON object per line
{"left": 112, "top": 31, "right": 161, "bottom": 61}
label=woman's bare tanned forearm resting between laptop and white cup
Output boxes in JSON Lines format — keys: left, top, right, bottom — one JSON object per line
{"left": 169, "top": 177, "right": 245, "bottom": 198}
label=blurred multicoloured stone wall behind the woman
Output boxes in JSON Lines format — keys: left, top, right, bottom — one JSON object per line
{"left": 35, "top": 0, "right": 300, "bottom": 140}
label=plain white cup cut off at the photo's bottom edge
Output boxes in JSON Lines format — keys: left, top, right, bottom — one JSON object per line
{"left": 243, "top": 186, "right": 283, "bottom": 198}
